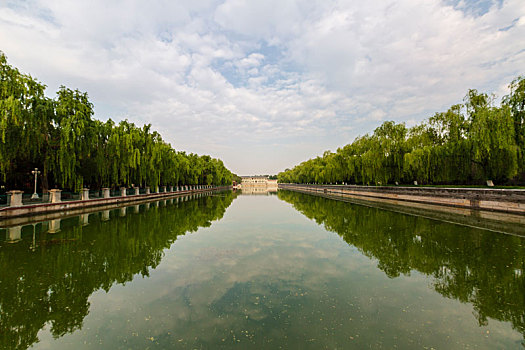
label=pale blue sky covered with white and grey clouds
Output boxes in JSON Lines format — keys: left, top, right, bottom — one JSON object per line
{"left": 0, "top": 0, "right": 525, "bottom": 175}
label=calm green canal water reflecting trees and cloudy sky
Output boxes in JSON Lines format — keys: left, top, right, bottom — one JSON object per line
{"left": 0, "top": 191, "right": 525, "bottom": 349}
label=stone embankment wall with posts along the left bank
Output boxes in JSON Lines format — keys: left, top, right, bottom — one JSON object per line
{"left": 0, "top": 186, "right": 231, "bottom": 222}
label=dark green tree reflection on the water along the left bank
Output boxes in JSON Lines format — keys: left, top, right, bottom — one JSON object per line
{"left": 0, "top": 192, "right": 236, "bottom": 349}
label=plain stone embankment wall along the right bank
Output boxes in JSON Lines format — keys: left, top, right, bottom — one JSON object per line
{"left": 279, "top": 183, "right": 525, "bottom": 215}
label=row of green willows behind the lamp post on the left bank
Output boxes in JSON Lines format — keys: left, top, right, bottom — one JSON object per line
{"left": 0, "top": 51, "right": 233, "bottom": 190}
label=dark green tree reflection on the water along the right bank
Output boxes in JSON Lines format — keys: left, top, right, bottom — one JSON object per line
{"left": 278, "top": 191, "right": 525, "bottom": 335}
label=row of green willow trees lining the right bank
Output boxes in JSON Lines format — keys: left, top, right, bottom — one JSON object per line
{"left": 278, "top": 77, "right": 525, "bottom": 185}
